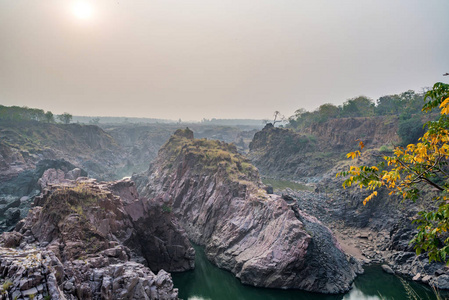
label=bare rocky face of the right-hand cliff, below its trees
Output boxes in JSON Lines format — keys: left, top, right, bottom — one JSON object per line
{"left": 248, "top": 117, "right": 399, "bottom": 182}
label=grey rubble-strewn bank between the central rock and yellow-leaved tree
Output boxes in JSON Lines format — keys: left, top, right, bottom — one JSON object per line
{"left": 282, "top": 189, "right": 449, "bottom": 290}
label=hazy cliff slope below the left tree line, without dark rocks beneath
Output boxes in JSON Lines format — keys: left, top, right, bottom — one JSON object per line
{"left": 0, "top": 122, "right": 124, "bottom": 180}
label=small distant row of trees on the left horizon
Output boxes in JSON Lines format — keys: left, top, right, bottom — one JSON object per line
{"left": 0, "top": 105, "right": 72, "bottom": 124}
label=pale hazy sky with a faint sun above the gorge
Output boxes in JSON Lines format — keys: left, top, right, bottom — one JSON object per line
{"left": 0, "top": 0, "right": 449, "bottom": 120}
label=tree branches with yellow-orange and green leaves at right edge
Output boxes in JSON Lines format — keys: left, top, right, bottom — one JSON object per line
{"left": 337, "top": 82, "right": 449, "bottom": 261}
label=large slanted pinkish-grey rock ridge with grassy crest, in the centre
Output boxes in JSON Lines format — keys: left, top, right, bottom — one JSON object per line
{"left": 135, "top": 129, "right": 357, "bottom": 293}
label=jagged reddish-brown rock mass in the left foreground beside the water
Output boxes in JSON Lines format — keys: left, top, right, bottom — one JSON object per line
{"left": 0, "top": 176, "right": 195, "bottom": 299}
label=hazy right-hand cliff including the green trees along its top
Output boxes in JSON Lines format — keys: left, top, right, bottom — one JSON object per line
{"left": 249, "top": 86, "right": 437, "bottom": 182}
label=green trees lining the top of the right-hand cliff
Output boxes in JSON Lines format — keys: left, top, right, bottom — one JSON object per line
{"left": 287, "top": 90, "right": 424, "bottom": 145}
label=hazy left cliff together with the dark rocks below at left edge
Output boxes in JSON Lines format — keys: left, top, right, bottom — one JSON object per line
{"left": 0, "top": 121, "right": 123, "bottom": 233}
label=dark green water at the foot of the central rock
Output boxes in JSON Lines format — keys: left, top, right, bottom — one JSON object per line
{"left": 173, "top": 247, "right": 444, "bottom": 300}
